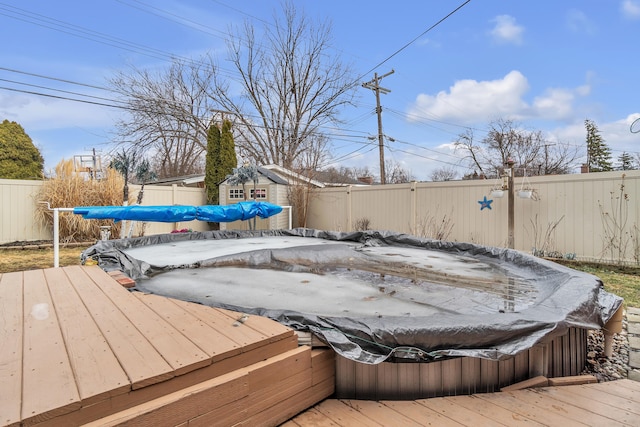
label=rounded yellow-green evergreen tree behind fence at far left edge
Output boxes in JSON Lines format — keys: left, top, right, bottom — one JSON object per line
{"left": 0, "top": 120, "right": 44, "bottom": 179}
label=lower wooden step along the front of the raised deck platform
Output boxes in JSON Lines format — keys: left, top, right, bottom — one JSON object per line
{"left": 87, "top": 346, "right": 335, "bottom": 427}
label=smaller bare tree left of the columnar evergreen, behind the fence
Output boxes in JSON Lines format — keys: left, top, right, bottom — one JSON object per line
{"left": 110, "top": 60, "right": 216, "bottom": 177}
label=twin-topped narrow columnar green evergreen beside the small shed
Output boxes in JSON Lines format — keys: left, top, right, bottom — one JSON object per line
{"left": 204, "top": 120, "right": 238, "bottom": 205}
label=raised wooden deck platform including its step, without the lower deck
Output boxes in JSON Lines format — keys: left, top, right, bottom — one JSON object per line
{"left": 0, "top": 266, "right": 335, "bottom": 426}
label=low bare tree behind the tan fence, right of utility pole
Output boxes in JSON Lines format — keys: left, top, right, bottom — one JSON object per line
{"left": 455, "top": 119, "right": 578, "bottom": 178}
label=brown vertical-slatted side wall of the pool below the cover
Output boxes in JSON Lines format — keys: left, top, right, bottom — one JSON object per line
{"left": 336, "top": 328, "right": 587, "bottom": 400}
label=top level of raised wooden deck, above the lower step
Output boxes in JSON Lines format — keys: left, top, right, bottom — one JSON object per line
{"left": 0, "top": 266, "right": 298, "bottom": 427}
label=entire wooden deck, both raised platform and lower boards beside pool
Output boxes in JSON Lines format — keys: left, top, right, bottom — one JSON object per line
{"left": 0, "top": 266, "right": 640, "bottom": 427}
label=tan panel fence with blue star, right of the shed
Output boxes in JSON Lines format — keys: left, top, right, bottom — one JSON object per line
{"left": 308, "top": 171, "right": 640, "bottom": 263}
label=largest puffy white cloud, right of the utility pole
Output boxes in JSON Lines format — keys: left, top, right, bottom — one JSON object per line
{"left": 408, "top": 71, "right": 591, "bottom": 124}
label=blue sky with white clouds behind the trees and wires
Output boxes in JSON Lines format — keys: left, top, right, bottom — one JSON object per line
{"left": 0, "top": 0, "right": 640, "bottom": 180}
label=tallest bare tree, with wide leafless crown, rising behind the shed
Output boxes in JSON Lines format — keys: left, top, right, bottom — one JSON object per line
{"left": 212, "top": 3, "right": 356, "bottom": 169}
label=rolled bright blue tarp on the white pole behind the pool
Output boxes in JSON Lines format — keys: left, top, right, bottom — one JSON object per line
{"left": 73, "top": 201, "right": 282, "bottom": 222}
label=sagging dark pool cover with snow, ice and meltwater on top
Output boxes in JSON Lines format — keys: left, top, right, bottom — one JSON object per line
{"left": 83, "top": 229, "right": 622, "bottom": 363}
